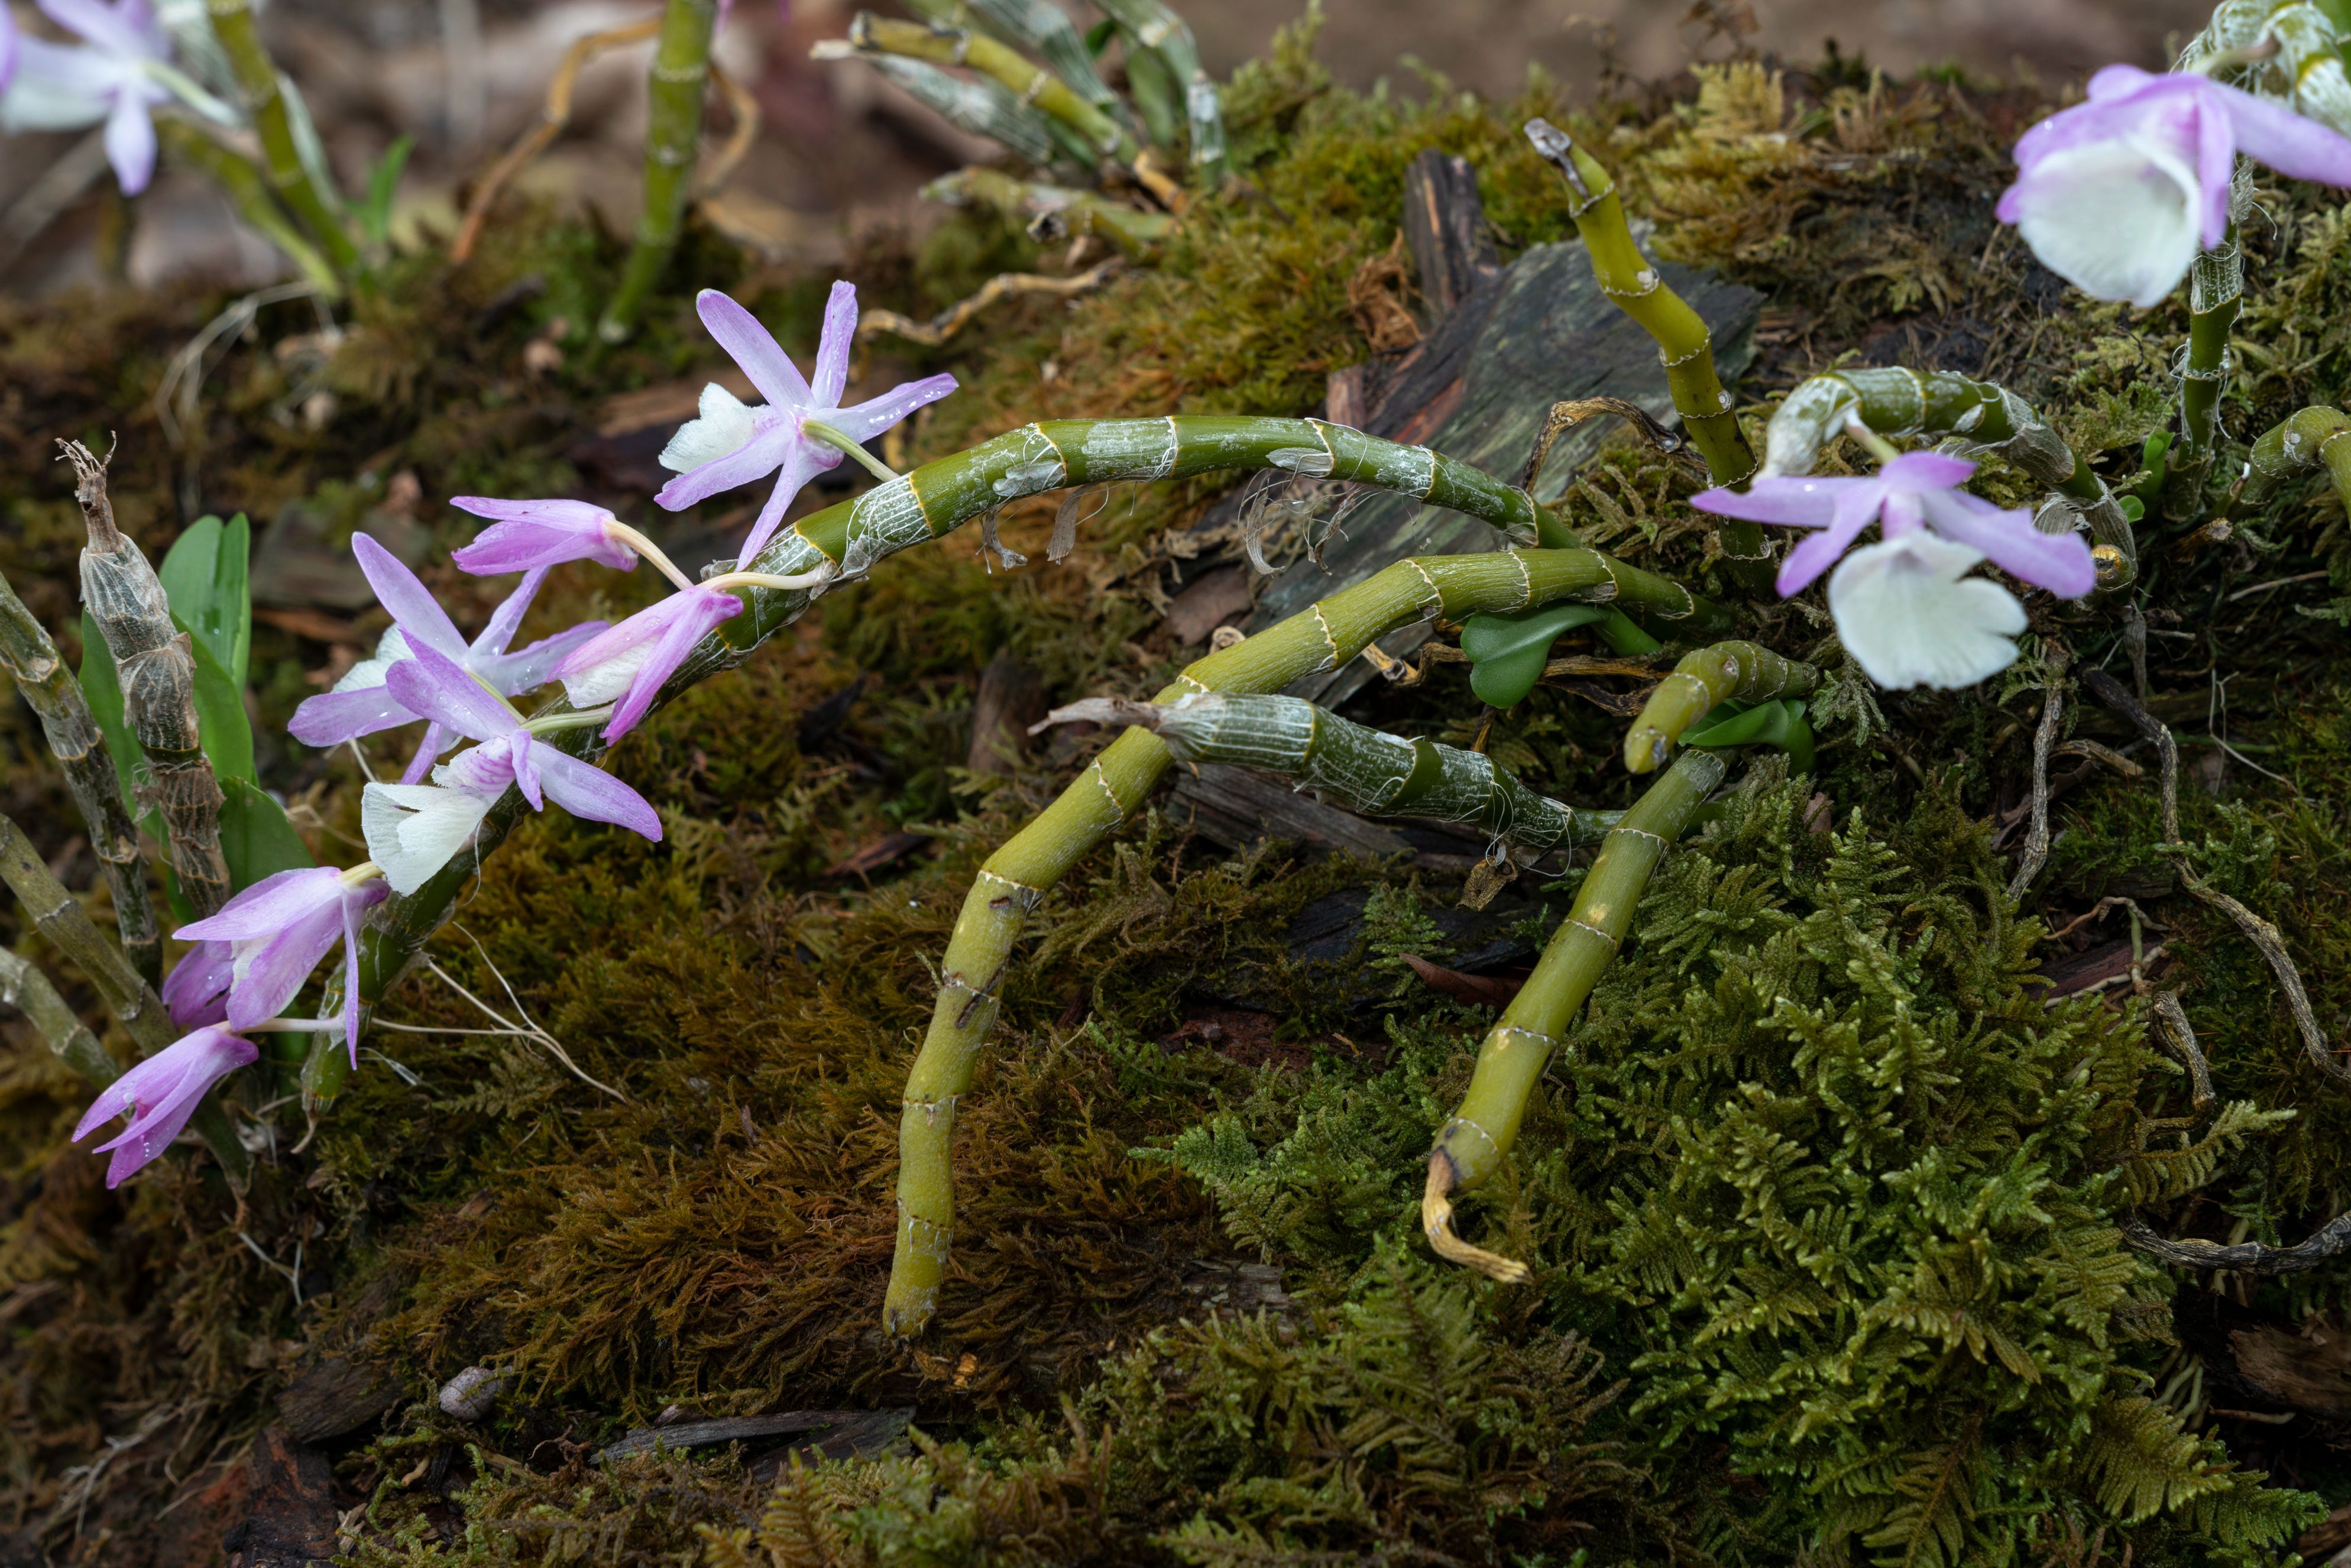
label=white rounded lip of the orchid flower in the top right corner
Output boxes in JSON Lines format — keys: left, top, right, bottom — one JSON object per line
{"left": 2017, "top": 137, "right": 2203, "bottom": 310}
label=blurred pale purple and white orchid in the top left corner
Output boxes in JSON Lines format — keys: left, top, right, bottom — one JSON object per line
{"left": 0, "top": 0, "right": 177, "bottom": 195}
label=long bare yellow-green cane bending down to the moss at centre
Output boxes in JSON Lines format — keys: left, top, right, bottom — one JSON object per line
{"left": 882, "top": 550, "right": 1681, "bottom": 1333}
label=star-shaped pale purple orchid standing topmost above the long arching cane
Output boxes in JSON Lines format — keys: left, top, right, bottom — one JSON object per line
{"left": 653, "top": 282, "right": 954, "bottom": 564}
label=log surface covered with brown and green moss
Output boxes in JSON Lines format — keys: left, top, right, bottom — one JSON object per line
{"left": 0, "top": 35, "right": 2351, "bottom": 1568}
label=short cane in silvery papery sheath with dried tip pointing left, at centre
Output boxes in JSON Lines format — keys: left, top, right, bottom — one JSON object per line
{"left": 1048, "top": 691, "right": 1617, "bottom": 851}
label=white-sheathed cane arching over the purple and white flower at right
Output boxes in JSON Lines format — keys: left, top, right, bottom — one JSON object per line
{"left": 1761, "top": 364, "right": 2139, "bottom": 590}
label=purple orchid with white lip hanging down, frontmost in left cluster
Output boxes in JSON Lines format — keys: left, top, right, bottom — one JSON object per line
{"left": 362, "top": 649, "right": 660, "bottom": 891}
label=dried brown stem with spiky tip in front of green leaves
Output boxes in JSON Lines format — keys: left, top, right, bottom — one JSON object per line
{"left": 59, "top": 442, "right": 228, "bottom": 919}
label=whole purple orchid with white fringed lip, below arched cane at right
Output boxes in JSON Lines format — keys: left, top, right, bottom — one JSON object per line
{"left": 1691, "top": 451, "right": 2097, "bottom": 691}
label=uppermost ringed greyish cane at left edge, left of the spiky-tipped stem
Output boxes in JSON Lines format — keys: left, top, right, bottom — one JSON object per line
{"left": 0, "top": 564, "right": 162, "bottom": 985}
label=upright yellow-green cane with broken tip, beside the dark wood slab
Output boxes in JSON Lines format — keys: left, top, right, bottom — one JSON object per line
{"left": 1526, "top": 120, "right": 1773, "bottom": 592}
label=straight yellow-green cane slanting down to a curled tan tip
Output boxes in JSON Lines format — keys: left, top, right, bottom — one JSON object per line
{"left": 1420, "top": 750, "right": 1728, "bottom": 1284}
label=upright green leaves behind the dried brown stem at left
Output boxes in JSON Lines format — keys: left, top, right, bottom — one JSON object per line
{"left": 80, "top": 515, "right": 313, "bottom": 922}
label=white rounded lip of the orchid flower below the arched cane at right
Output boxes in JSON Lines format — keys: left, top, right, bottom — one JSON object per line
{"left": 1829, "top": 534, "right": 2024, "bottom": 691}
